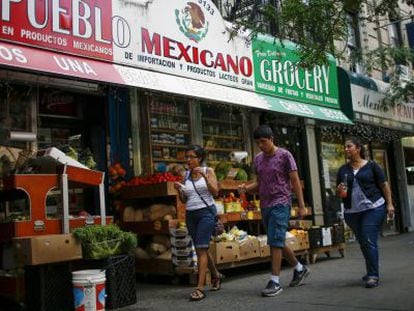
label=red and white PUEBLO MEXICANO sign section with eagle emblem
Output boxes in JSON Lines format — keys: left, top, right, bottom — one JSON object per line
{"left": 0, "top": 0, "right": 254, "bottom": 90}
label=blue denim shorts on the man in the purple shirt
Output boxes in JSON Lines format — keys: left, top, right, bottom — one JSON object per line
{"left": 261, "top": 204, "right": 290, "bottom": 248}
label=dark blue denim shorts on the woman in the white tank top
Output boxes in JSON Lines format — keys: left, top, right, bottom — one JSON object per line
{"left": 185, "top": 205, "right": 217, "bottom": 248}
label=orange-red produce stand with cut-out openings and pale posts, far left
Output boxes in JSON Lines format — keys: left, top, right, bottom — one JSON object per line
{"left": 0, "top": 165, "right": 111, "bottom": 242}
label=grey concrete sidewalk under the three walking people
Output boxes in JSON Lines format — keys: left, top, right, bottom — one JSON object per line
{"left": 121, "top": 232, "right": 414, "bottom": 311}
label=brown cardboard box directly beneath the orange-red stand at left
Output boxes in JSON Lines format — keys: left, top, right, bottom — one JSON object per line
{"left": 13, "top": 234, "right": 82, "bottom": 265}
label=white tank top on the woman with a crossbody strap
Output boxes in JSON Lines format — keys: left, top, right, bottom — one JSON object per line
{"left": 184, "top": 167, "right": 214, "bottom": 211}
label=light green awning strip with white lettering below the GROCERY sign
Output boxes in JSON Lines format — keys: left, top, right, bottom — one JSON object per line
{"left": 257, "top": 94, "right": 353, "bottom": 124}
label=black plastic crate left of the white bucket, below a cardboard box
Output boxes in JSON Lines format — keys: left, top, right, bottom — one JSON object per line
{"left": 25, "top": 262, "right": 74, "bottom": 311}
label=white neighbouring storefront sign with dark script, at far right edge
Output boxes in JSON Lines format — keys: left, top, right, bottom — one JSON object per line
{"left": 351, "top": 83, "right": 414, "bottom": 130}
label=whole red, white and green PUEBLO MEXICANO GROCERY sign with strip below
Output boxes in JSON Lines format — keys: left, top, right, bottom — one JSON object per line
{"left": 0, "top": 0, "right": 344, "bottom": 120}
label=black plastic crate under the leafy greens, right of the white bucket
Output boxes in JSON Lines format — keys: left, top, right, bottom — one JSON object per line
{"left": 83, "top": 254, "right": 137, "bottom": 309}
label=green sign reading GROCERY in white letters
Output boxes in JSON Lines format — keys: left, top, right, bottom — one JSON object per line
{"left": 252, "top": 36, "right": 339, "bottom": 109}
